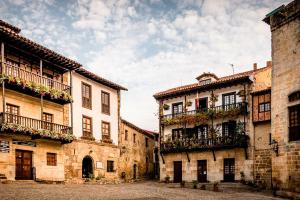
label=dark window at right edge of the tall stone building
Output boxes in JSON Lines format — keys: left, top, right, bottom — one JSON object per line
{"left": 289, "top": 104, "right": 300, "bottom": 141}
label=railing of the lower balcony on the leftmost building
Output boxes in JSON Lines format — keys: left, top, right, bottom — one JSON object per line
{"left": 0, "top": 113, "right": 72, "bottom": 136}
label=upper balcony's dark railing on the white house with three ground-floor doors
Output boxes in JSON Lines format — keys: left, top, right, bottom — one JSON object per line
{"left": 162, "top": 102, "right": 247, "bottom": 119}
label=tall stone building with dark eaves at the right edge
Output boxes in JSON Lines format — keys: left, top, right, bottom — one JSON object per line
{"left": 264, "top": 0, "right": 300, "bottom": 193}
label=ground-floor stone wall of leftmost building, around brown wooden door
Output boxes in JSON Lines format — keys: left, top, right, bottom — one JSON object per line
{"left": 0, "top": 133, "right": 64, "bottom": 181}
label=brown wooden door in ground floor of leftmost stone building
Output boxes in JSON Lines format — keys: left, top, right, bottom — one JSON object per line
{"left": 16, "top": 150, "right": 32, "bottom": 180}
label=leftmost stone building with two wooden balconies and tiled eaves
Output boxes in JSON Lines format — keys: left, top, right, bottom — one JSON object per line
{"left": 0, "top": 20, "right": 81, "bottom": 181}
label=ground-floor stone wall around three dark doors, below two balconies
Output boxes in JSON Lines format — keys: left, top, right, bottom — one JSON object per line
{"left": 160, "top": 148, "right": 253, "bottom": 182}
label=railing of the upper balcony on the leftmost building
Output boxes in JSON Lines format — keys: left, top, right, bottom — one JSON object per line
{"left": 0, "top": 63, "right": 71, "bottom": 94}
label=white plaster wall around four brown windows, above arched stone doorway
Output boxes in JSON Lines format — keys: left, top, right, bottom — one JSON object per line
{"left": 72, "top": 73, "right": 119, "bottom": 145}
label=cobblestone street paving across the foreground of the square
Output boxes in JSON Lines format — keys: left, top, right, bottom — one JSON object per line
{"left": 0, "top": 182, "right": 286, "bottom": 200}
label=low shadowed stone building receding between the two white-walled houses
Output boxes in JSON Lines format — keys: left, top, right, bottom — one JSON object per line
{"left": 119, "top": 119, "right": 158, "bottom": 180}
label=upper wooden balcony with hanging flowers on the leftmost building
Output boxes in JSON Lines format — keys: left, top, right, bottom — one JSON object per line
{"left": 0, "top": 63, "right": 72, "bottom": 104}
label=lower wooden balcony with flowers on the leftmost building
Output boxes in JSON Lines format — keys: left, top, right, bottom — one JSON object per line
{"left": 0, "top": 113, "right": 74, "bottom": 143}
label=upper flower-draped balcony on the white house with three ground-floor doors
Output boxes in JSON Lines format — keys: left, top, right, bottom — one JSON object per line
{"left": 161, "top": 102, "right": 248, "bottom": 125}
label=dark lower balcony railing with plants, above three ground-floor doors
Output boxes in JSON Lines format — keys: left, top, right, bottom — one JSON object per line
{"left": 160, "top": 133, "right": 248, "bottom": 153}
